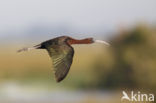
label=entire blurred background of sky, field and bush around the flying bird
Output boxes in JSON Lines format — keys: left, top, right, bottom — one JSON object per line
{"left": 0, "top": 0, "right": 156, "bottom": 103}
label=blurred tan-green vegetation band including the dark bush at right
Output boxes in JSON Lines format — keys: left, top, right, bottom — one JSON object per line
{"left": 0, "top": 25, "right": 156, "bottom": 94}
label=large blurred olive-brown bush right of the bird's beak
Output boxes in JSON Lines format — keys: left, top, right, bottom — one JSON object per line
{"left": 86, "top": 26, "right": 156, "bottom": 91}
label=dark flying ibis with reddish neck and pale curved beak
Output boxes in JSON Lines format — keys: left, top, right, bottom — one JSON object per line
{"left": 17, "top": 36, "right": 109, "bottom": 82}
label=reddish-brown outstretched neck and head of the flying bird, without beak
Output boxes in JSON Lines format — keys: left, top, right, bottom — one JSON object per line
{"left": 68, "top": 38, "right": 93, "bottom": 44}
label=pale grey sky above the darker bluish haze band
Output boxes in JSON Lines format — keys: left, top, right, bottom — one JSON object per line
{"left": 0, "top": 0, "right": 156, "bottom": 37}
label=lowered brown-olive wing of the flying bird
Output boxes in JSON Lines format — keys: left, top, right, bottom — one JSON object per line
{"left": 46, "top": 43, "right": 74, "bottom": 82}
